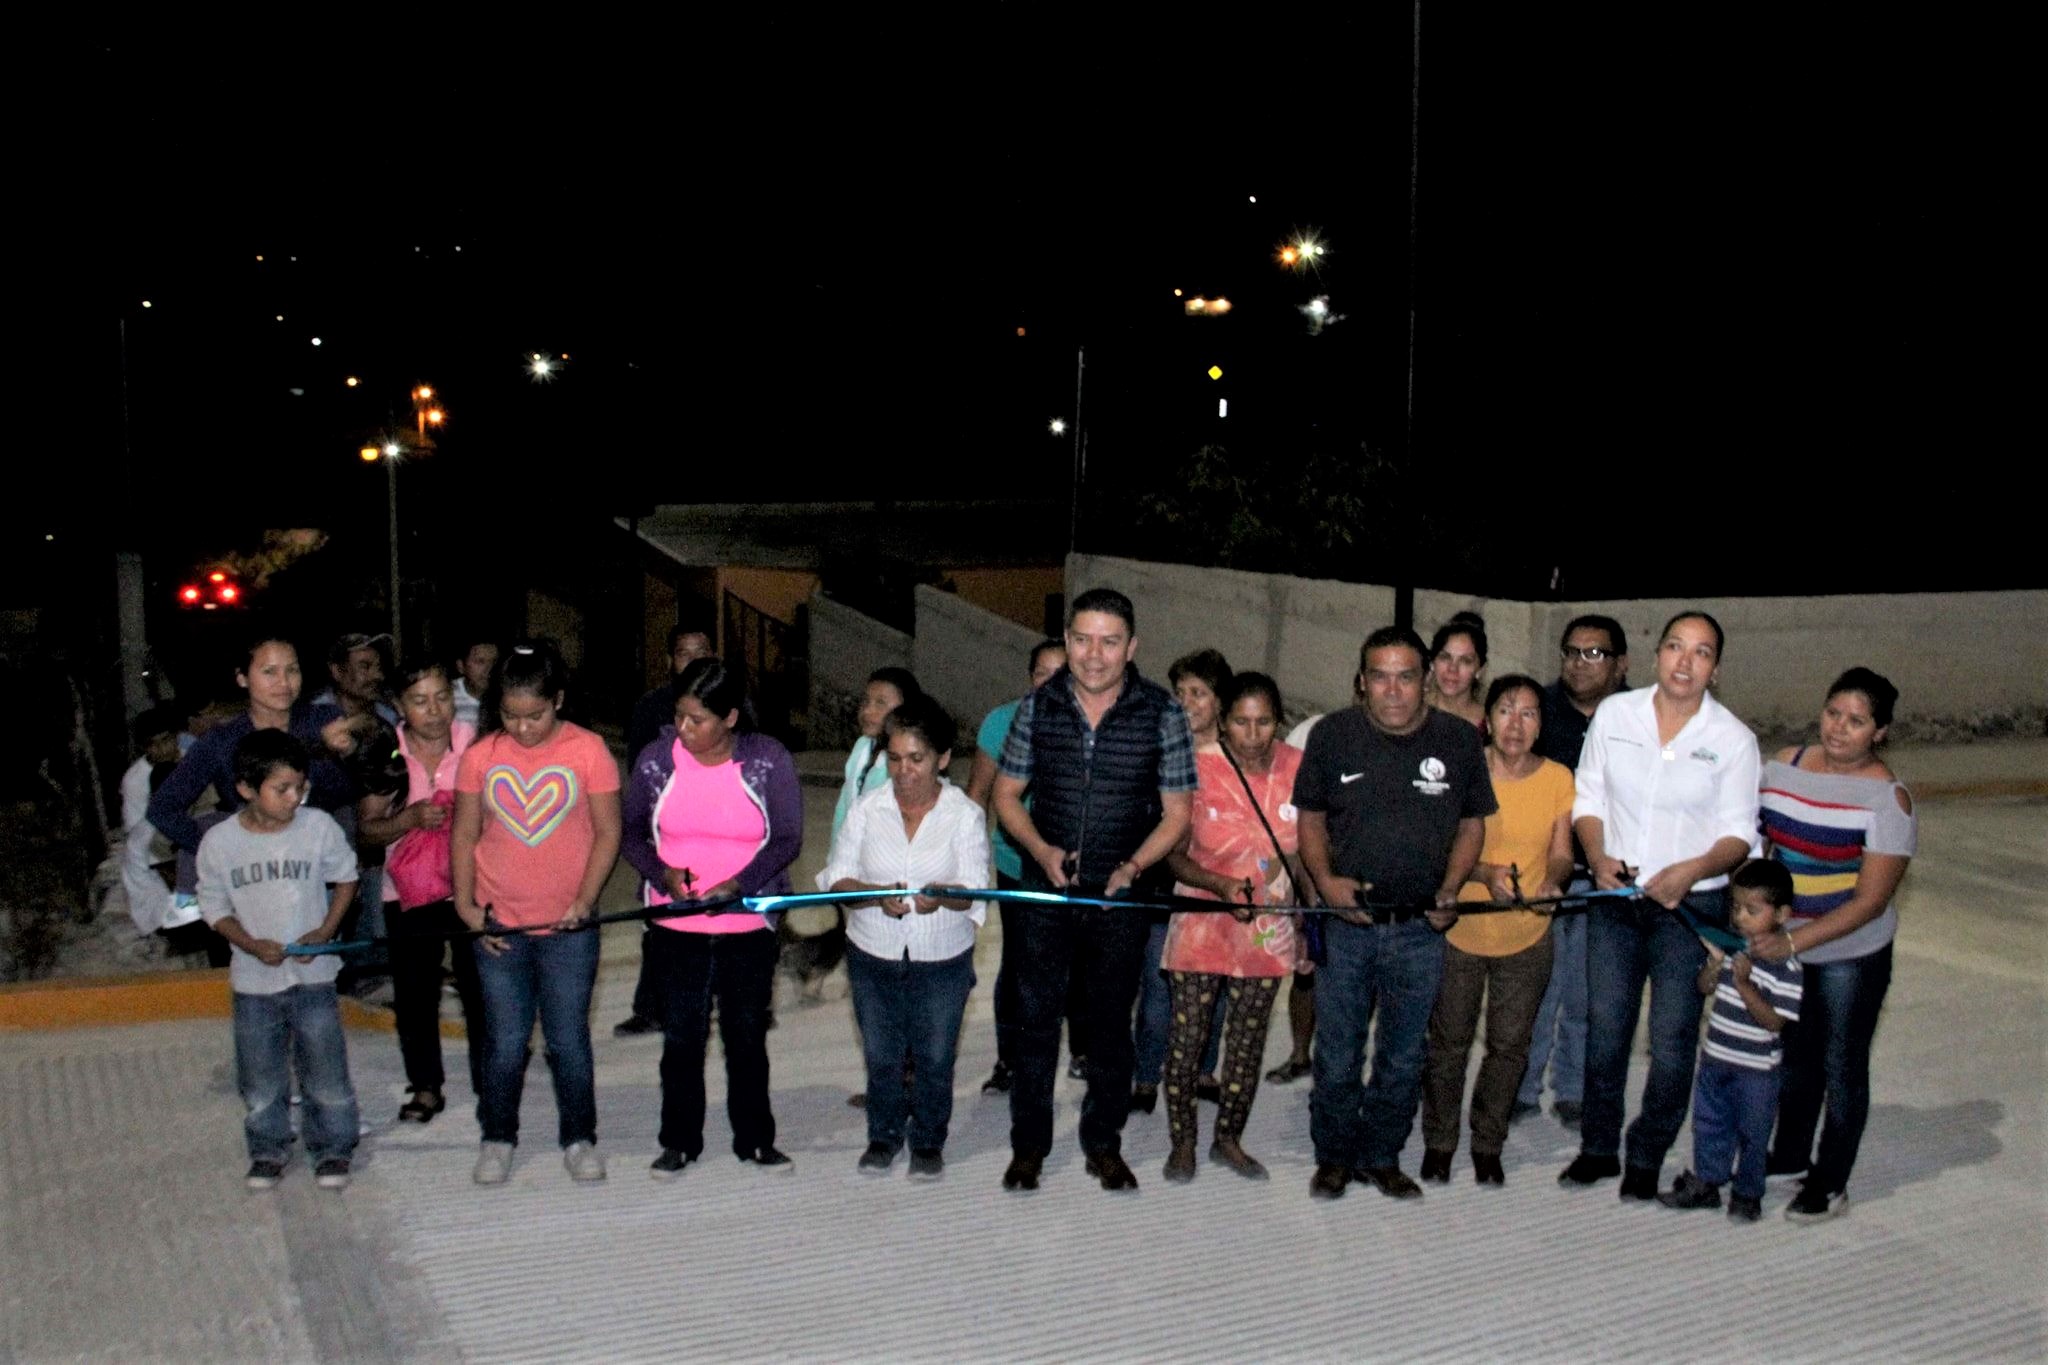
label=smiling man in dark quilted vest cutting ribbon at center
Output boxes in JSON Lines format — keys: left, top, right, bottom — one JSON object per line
{"left": 995, "top": 587, "right": 1194, "bottom": 1189}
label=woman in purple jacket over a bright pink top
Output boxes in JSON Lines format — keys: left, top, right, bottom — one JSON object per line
{"left": 625, "top": 659, "right": 803, "bottom": 1181}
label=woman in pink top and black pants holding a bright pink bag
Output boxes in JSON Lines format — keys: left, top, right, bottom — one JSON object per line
{"left": 356, "top": 661, "right": 483, "bottom": 1124}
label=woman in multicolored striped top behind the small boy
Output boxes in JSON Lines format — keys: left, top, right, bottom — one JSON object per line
{"left": 1749, "top": 667, "right": 1917, "bottom": 1222}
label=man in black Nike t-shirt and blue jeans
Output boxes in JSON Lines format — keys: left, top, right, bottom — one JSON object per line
{"left": 1294, "top": 626, "right": 1495, "bottom": 1199}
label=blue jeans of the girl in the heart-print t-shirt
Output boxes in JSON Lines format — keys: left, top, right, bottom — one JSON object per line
{"left": 475, "top": 929, "right": 598, "bottom": 1146}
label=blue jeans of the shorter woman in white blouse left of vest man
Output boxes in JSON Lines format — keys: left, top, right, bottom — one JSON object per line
{"left": 846, "top": 945, "right": 975, "bottom": 1152}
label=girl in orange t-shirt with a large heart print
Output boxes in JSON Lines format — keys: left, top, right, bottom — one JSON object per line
{"left": 453, "top": 641, "right": 618, "bottom": 1185}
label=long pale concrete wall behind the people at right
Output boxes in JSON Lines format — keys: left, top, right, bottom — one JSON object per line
{"left": 1064, "top": 555, "right": 2048, "bottom": 739}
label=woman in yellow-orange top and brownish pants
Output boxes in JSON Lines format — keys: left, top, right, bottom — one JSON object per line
{"left": 1421, "top": 673, "right": 1573, "bottom": 1185}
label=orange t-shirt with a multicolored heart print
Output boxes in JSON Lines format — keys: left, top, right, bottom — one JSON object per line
{"left": 455, "top": 720, "right": 618, "bottom": 929}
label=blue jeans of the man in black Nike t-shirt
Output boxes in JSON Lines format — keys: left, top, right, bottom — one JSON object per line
{"left": 1309, "top": 915, "right": 1444, "bottom": 1171}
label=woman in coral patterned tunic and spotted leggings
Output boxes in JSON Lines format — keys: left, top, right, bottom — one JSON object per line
{"left": 1161, "top": 673, "right": 1307, "bottom": 1183}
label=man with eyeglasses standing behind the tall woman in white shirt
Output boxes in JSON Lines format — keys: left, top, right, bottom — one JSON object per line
{"left": 1509, "top": 616, "right": 1628, "bottom": 1128}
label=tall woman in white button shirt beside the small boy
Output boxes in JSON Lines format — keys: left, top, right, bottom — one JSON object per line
{"left": 1559, "top": 612, "right": 1761, "bottom": 1199}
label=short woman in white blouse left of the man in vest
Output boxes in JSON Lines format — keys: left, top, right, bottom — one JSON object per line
{"left": 821, "top": 696, "right": 989, "bottom": 1181}
